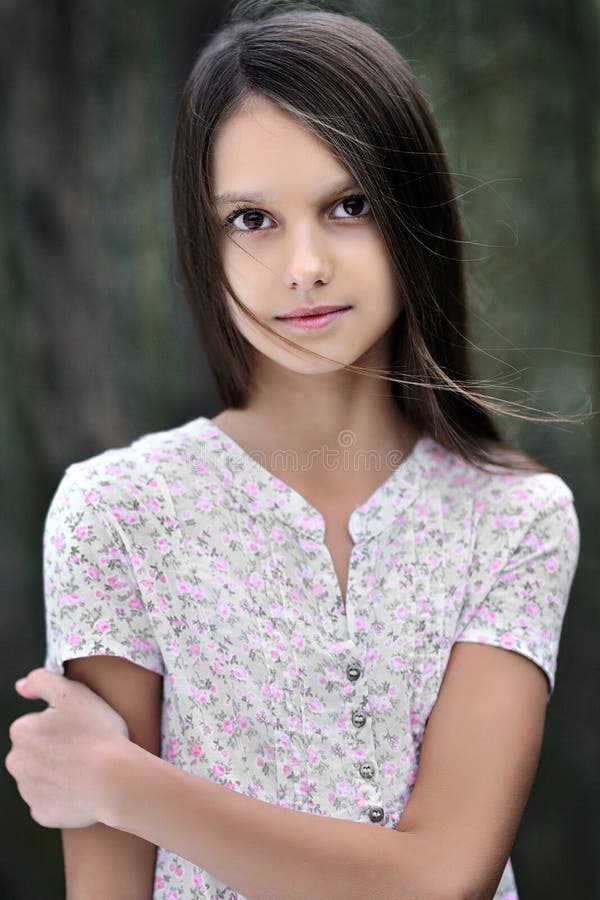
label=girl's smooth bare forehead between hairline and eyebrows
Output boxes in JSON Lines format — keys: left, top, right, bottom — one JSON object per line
{"left": 211, "top": 98, "right": 348, "bottom": 203}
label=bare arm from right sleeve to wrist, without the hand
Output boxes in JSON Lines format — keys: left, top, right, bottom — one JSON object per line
{"left": 99, "top": 643, "right": 548, "bottom": 900}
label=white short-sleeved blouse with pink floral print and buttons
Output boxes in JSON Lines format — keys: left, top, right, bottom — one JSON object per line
{"left": 44, "top": 417, "right": 579, "bottom": 900}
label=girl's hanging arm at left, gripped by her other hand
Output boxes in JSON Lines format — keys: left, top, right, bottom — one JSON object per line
{"left": 62, "top": 656, "right": 162, "bottom": 900}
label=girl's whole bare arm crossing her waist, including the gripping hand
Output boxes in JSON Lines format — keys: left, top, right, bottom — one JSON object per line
{"left": 6, "top": 642, "right": 548, "bottom": 900}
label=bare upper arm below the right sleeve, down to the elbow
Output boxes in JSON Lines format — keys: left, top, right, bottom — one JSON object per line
{"left": 397, "top": 642, "right": 549, "bottom": 900}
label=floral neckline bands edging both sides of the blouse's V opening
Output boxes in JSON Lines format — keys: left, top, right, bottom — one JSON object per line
{"left": 194, "top": 416, "right": 435, "bottom": 544}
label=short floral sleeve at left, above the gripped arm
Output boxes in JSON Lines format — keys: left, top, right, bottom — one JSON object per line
{"left": 44, "top": 469, "right": 164, "bottom": 674}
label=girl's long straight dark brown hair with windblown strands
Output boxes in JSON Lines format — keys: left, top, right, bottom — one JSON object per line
{"left": 171, "top": 2, "right": 580, "bottom": 471}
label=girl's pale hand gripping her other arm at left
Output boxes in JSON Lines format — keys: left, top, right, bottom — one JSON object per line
{"left": 5, "top": 669, "right": 129, "bottom": 828}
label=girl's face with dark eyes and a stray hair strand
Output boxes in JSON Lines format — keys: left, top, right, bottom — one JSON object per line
{"left": 212, "top": 98, "right": 401, "bottom": 374}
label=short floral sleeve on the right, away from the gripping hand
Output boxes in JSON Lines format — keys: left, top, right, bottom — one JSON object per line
{"left": 454, "top": 475, "right": 580, "bottom": 702}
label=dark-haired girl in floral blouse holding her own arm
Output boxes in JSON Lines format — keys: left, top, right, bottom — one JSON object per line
{"left": 7, "top": 5, "right": 579, "bottom": 900}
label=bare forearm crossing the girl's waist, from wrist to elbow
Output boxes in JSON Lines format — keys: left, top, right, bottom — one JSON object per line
{"left": 103, "top": 743, "right": 432, "bottom": 900}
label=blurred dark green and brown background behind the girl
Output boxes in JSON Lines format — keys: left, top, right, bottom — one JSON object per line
{"left": 0, "top": 0, "right": 600, "bottom": 900}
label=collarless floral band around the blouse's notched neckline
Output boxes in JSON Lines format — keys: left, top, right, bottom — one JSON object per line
{"left": 193, "top": 416, "right": 439, "bottom": 543}
